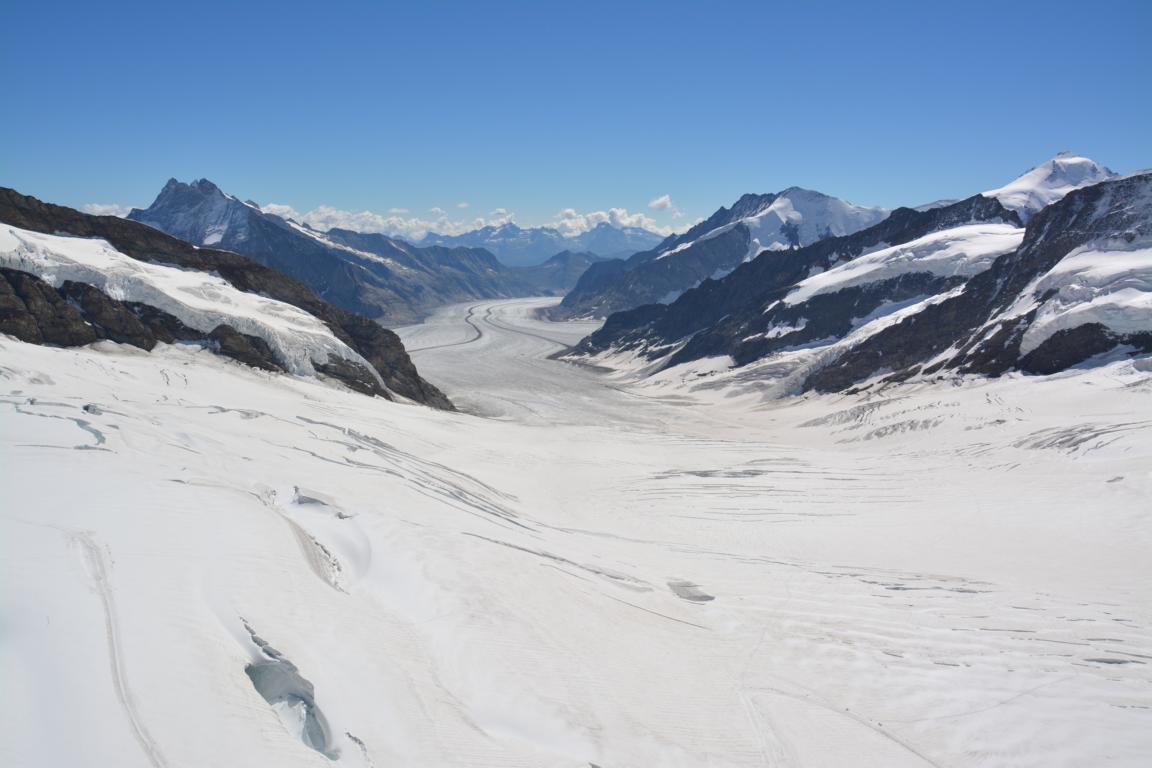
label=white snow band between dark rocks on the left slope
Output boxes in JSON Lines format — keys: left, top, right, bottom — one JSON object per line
{"left": 0, "top": 225, "right": 382, "bottom": 385}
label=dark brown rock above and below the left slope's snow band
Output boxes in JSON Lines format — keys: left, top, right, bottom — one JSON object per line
{"left": 0, "top": 188, "right": 452, "bottom": 409}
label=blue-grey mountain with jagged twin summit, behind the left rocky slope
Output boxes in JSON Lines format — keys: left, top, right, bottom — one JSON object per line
{"left": 128, "top": 178, "right": 597, "bottom": 326}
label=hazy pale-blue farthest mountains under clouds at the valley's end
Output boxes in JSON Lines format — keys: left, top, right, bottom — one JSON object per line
{"left": 419, "top": 222, "right": 664, "bottom": 266}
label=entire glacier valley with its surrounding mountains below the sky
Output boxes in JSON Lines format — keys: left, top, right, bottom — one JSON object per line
{"left": 0, "top": 153, "right": 1152, "bottom": 768}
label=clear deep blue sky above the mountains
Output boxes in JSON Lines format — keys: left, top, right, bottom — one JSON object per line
{"left": 0, "top": 0, "right": 1152, "bottom": 237}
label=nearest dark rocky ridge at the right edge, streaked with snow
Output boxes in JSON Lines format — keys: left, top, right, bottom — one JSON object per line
{"left": 809, "top": 174, "right": 1152, "bottom": 390}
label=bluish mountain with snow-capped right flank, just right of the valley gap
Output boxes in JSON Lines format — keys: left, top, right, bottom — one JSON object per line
{"left": 551, "top": 188, "right": 888, "bottom": 319}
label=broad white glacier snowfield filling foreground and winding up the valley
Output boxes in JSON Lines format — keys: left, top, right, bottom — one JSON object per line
{"left": 0, "top": 299, "right": 1152, "bottom": 768}
